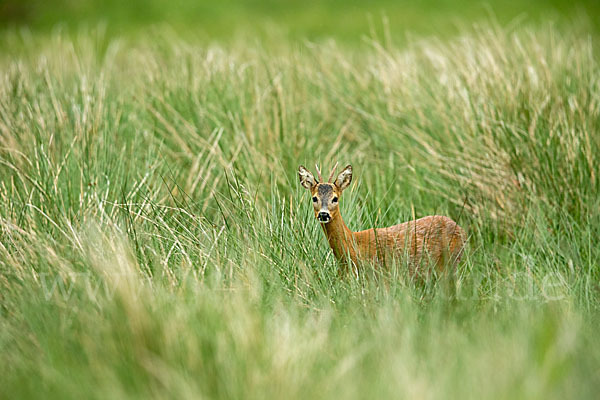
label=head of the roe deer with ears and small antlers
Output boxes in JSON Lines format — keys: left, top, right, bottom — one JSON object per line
{"left": 298, "top": 164, "right": 352, "bottom": 224}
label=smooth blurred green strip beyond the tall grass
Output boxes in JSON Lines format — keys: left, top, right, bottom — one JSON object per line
{"left": 0, "top": 0, "right": 600, "bottom": 42}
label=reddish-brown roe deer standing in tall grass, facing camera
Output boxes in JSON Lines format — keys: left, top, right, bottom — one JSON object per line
{"left": 298, "top": 164, "right": 465, "bottom": 272}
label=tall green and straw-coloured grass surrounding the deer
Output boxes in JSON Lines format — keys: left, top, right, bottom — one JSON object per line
{"left": 0, "top": 1, "right": 600, "bottom": 399}
